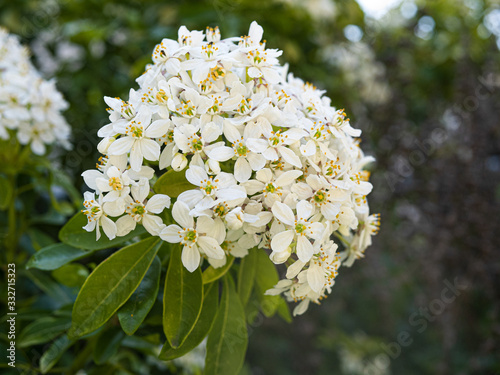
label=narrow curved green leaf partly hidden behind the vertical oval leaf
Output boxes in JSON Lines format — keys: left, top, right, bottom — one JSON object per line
{"left": 158, "top": 283, "right": 219, "bottom": 361}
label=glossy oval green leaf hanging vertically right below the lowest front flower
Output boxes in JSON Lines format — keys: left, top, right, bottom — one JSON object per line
{"left": 163, "top": 246, "right": 203, "bottom": 348}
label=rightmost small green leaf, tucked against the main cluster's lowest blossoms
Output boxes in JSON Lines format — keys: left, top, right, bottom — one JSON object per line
{"left": 254, "top": 249, "right": 282, "bottom": 318}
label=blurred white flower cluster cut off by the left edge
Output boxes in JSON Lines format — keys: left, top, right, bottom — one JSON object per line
{"left": 0, "top": 28, "right": 71, "bottom": 155}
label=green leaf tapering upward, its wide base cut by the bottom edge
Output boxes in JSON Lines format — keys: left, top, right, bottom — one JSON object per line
{"left": 205, "top": 274, "right": 248, "bottom": 375}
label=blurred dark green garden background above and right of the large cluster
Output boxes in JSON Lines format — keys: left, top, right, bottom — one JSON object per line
{"left": 0, "top": 0, "right": 500, "bottom": 375}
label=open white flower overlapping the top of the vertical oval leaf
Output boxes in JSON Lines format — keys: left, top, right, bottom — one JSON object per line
{"left": 160, "top": 201, "right": 224, "bottom": 272}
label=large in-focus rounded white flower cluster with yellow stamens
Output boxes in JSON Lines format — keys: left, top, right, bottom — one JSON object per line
{"left": 83, "top": 22, "right": 378, "bottom": 314}
